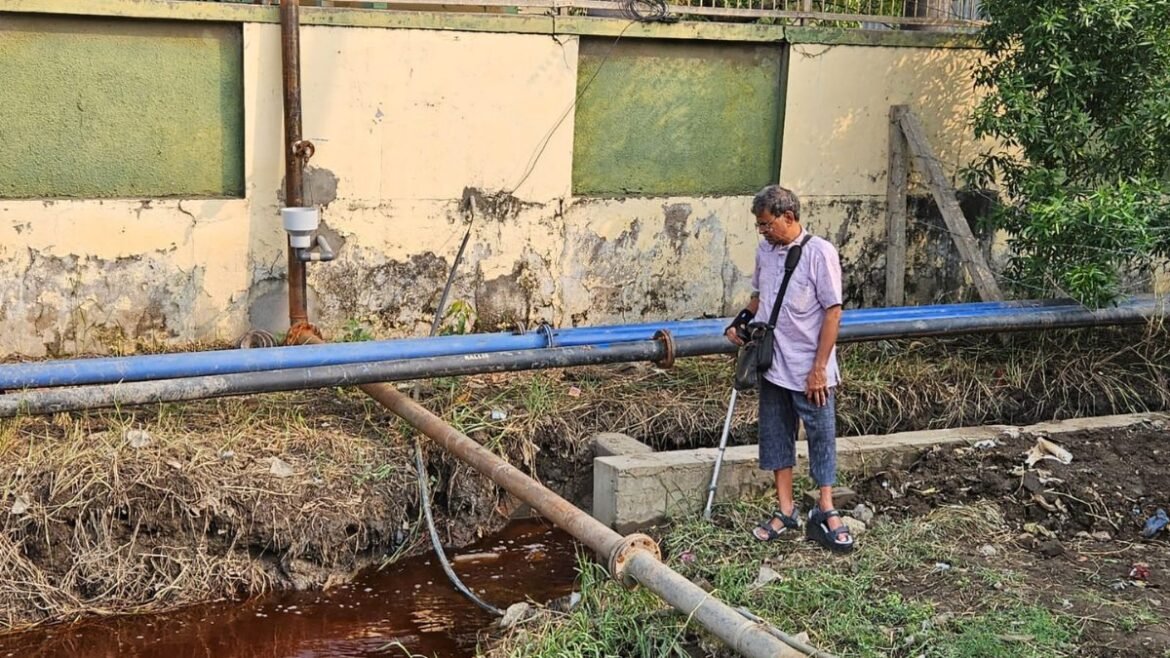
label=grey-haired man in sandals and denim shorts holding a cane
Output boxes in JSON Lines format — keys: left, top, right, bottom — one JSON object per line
{"left": 725, "top": 185, "right": 853, "bottom": 553}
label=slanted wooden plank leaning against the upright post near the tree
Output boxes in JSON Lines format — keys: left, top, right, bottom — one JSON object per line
{"left": 899, "top": 108, "right": 1004, "bottom": 302}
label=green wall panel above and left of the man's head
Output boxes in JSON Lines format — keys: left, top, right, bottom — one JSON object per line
{"left": 573, "top": 37, "right": 783, "bottom": 196}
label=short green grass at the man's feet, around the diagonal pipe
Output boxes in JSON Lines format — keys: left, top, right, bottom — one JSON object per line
{"left": 488, "top": 499, "right": 1079, "bottom": 658}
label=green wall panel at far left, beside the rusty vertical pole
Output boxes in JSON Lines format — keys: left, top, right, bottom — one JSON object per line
{"left": 0, "top": 14, "right": 243, "bottom": 198}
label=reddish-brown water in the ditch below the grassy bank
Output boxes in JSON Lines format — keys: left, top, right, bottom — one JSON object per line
{"left": 0, "top": 521, "right": 577, "bottom": 658}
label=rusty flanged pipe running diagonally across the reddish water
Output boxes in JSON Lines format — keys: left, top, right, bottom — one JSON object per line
{"left": 362, "top": 374, "right": 805, "bottom": 658}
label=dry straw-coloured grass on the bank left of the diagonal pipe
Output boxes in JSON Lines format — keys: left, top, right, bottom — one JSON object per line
{"left": 0, "top": 395, "right": 413, "bottom": 629}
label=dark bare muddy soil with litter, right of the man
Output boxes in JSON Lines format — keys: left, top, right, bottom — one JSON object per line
{"left": 855, "top": 420, "right": 1170, "bottom": 657}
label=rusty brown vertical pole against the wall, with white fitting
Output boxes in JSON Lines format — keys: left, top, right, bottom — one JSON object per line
{"left": 281, "top": 0, "right": 309, "bottom": 327}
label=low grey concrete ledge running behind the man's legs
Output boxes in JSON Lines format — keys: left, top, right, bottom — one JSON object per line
{"left": 593, "top": 413, "right": 1170, "bottom": 533}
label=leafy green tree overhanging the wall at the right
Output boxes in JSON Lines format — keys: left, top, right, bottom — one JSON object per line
{"left": 972, "top": 0, "right": 1170, "bottom": 306}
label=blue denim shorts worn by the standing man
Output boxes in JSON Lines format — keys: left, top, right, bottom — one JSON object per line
{"left": 759, "top": 378, "right": 837, "bottom": 487}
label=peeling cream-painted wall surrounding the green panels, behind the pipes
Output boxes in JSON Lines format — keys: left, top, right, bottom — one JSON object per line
{"left": 0, "top": 1, "right": 992, "bottom": 356}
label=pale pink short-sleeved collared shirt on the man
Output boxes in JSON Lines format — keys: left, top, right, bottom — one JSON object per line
{"left": 751, "top": 228, "right": 842, "bottom": 391}
